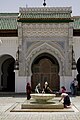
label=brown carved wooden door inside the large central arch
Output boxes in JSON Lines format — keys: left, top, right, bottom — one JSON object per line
{"left": 31, "top": 58, "right": 59, "bottom": 91}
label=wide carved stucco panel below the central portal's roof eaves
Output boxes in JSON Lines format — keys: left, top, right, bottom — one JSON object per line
{"left": 23, "top": 23, "right": 68, "bottom": 37}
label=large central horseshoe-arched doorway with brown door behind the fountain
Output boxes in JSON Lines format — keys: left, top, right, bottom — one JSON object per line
{"left": 31, "top": 53, "right": 60, "bottom": 91}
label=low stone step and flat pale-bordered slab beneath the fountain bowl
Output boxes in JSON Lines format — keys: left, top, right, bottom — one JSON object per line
{"left": 10, "top": 100, "right": 78, "bottom": 112}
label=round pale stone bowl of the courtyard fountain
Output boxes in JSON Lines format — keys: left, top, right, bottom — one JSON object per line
{"left": 31, "top": 93, "right": 56, "bottom": 103}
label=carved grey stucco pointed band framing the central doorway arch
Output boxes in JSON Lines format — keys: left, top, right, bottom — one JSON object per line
{"left": 26, "top": 43, "right": 65, "bottom": 75}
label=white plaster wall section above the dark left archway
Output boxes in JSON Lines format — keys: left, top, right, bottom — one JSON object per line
{"left": 0, "top": 37, "right": 18, "bottom": 59}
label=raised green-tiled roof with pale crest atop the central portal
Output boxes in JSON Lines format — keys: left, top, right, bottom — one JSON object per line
{"left": 19, "top": 7, "right": 72, "bottom": 18}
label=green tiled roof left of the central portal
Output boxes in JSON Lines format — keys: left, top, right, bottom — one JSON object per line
{"left": 0, "top": 13, "right": 19, "bottom": 30}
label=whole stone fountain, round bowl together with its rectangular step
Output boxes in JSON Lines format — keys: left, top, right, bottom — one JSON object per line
{"left": 21, "top": 93, "right": 64, "bottom": 111}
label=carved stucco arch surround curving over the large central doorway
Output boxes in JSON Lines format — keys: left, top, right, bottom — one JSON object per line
{"left": 26, "top": 42, "right": 64, "bottom": 76}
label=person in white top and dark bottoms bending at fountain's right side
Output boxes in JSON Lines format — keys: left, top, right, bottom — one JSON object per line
{"left": 59, "top": 93, "right": 71, "bottom": 108}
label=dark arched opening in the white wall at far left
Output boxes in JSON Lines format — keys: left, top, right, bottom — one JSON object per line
{"left": 0, "top": 54, "right": 15, "bottom": 92}
